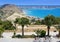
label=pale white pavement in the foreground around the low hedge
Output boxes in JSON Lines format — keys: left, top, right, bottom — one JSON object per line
{"left": 0, "top": 32, "right": 60, "bottom": 42}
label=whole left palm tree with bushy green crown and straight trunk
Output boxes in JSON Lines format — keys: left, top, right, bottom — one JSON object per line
{"left": 16, "top": 17, "right": 29, "bottom": 37}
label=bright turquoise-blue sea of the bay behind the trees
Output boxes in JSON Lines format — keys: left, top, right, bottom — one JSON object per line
{"left": 18, "top": 6, "right": 60, "bottom": 18}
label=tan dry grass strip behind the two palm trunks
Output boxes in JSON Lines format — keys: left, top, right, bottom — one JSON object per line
{"left": 5, "top": 25, "right": 56, "bottom": 32}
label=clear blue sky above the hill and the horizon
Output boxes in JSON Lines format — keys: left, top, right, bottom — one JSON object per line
{"left": 0, "top": 0, "right": 60, "bottom": 5}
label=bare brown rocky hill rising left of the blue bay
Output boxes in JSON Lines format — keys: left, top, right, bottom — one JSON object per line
{"left": 0, "top": 4, "right": 24, "bottom": 20}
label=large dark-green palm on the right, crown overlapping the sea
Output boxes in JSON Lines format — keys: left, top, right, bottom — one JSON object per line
{"left": 44, "top": 15, "right": 55, "bottom": 36}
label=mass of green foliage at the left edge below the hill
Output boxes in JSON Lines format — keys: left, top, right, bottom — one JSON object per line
{"left": 0, "top": 20, "right": 15, "bottom": 37}
